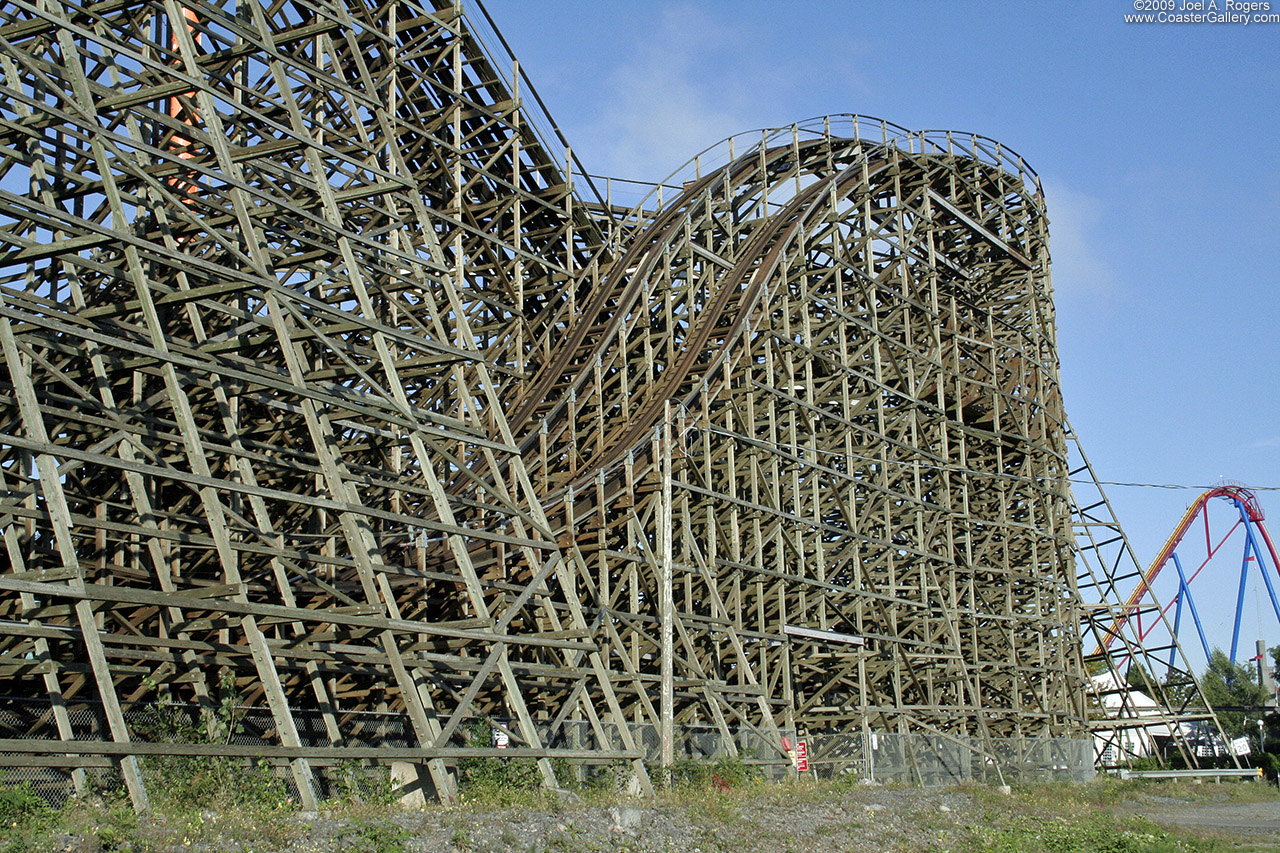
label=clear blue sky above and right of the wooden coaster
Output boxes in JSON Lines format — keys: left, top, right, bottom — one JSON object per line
{"left": 486, "top": 0, "right": 1280, "bottom": 660}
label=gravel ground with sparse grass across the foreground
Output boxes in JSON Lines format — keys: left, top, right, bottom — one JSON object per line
{"left": 35, "top": 784, "right": 1280, "bottom": 853}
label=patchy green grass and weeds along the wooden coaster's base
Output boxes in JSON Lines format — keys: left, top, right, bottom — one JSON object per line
{"left": 0, "top": 762, "right": 1280, "bottom": 853}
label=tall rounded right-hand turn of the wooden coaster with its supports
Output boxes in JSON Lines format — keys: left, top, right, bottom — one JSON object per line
{"left": 512, "top": 117, "right": 1083, "bottom": 736}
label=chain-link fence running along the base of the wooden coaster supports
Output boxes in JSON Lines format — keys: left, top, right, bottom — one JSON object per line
{"left": 0, "top": 698, "right": 1094, "bottom": 806}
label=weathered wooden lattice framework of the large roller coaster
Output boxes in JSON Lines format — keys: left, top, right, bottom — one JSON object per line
{"left": 0, "top": 0, "right": 1084, "bottom": 807}
